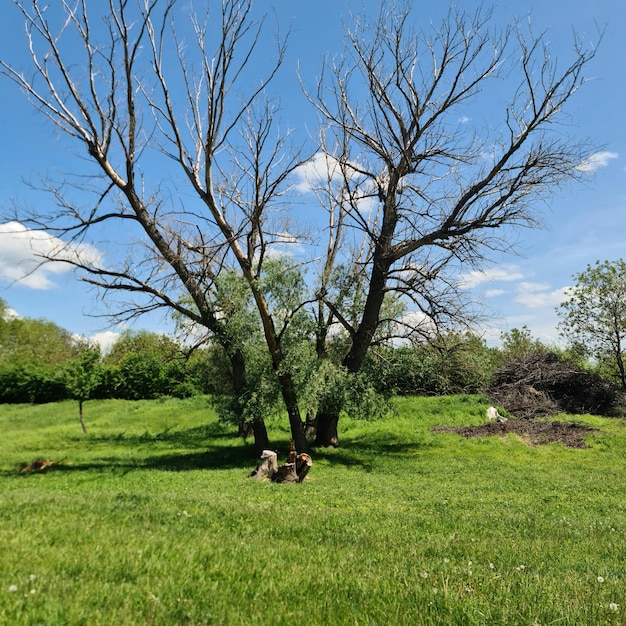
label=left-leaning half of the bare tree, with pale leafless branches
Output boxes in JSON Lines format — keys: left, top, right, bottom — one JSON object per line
{"left": 0, "top": 0, "right": 306, "bottom": 451}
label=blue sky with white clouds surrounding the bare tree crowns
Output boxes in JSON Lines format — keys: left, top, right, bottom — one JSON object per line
{"left": 0, "top": 0, "right": 626, "bottom": 352}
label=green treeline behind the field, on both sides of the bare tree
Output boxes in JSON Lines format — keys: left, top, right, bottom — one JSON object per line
{"left": 0, "top": 303, "right": 573, "bottom": 403}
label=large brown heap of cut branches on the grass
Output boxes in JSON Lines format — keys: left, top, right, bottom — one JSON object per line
{"left": 486, "top": 352, "right": 623, "bottom": 419}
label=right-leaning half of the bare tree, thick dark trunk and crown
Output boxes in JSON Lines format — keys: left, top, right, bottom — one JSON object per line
{"left": 308, "top": 1, "right": 595, "bottom": 445}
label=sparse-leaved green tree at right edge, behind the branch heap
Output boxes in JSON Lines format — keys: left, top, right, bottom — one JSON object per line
{"left": 557, "top": 259, "right": 626, "bottom": 389}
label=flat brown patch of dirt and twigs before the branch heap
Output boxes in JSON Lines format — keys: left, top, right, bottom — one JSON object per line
{"left": 433, "top": 419, "right": 595, "bottom": 448}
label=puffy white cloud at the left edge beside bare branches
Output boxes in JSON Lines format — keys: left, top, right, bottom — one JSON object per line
{"left": 0, "top": 222, "right": 102, "bottom": 289}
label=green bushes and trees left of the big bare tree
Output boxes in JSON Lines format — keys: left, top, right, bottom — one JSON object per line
{"left": 0, "top": 307, "right": 220, "bottom": 403}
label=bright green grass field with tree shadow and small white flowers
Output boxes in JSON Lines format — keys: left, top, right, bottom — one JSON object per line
{"left": 0, "top": 396, "right": 626, "bottom": 626}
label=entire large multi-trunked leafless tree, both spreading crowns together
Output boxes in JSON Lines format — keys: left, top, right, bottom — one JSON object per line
{"left": 0, "top": 0, "right": 594, "bottom": 452}
